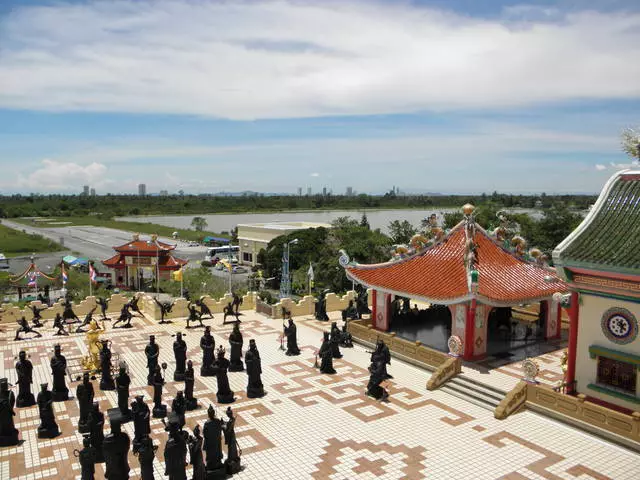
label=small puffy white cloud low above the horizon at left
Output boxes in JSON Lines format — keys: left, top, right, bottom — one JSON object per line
{"left": 17, "top": 159, "right": 107, "bottom": 192}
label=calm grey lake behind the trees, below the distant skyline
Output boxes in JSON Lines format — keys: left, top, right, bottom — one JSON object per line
{"left": 116, "top": 208, "right": 542, "bottom": 233}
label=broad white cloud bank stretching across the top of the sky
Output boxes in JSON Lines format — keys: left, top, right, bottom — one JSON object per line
{"left": 0, "top": 0, "right": 640, "bottom": 119}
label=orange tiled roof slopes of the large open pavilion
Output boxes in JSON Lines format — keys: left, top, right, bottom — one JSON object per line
{"left": 346, "top": 223, "right": 568, "bottom": 305}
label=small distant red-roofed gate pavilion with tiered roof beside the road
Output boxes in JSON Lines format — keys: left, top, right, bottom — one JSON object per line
{"left": 102, "top": 234, "right": 187, "bottom": 288}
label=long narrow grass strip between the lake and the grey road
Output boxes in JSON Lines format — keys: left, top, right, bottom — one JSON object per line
{"left": 12, "top": 215, "right": 229, "bottom": 244}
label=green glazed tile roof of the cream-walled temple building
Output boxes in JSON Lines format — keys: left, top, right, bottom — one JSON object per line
{"left": 559, "top": 172, "right": 640, "bottom": 275}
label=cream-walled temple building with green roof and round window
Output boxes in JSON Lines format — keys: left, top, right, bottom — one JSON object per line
{"left": 553, "top": 170, "right": 640, "bottom": 411}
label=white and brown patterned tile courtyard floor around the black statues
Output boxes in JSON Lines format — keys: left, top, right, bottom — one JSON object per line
{"left": 0, "top": 312, "right": 640, "bottom": 480}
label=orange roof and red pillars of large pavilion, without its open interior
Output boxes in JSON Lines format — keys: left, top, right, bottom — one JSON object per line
{"left": 340, "top": 205, "right": 568, "bottom": 360}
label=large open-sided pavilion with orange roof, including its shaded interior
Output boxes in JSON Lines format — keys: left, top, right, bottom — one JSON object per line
{"left": 340, "top": 205, "right": 568, "bottom": 360}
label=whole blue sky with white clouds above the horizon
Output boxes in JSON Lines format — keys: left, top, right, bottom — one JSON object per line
{"left": 0, "top": 0, "right": 640, "bottom": 194}
